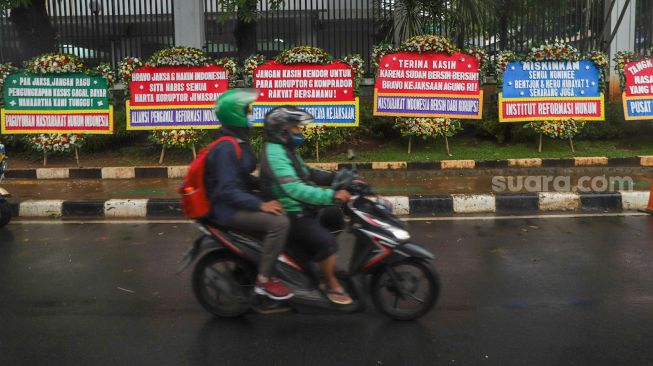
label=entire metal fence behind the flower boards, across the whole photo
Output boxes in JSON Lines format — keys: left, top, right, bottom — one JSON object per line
{"left": 0, "top": 0, "right": 653, "bottom": 70}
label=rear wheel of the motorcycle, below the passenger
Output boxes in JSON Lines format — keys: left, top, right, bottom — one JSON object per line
{"left": 192, "top": 252, "right": 256, "bottom": 318}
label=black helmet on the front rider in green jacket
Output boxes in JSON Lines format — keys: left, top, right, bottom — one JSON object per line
{"left": 263, "top": 106, "right": 313, "bottom": 145}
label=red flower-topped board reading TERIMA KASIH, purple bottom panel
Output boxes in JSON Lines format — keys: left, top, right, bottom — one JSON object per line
{"left": 374, "top": 35, "right": 483, "bottom": 119}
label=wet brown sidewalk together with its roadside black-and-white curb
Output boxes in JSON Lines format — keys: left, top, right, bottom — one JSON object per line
{"left": 2, "top": 167, "right": 653, "bottom": 218}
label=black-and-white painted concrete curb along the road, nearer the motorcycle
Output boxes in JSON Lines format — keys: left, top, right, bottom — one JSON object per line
{"left": 8, "top": 191, "right": 649, "bottom": 218}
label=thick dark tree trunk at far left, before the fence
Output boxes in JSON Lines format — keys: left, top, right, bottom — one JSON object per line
{"left": 10, "top": 0, "right": 55, "bottom": 61}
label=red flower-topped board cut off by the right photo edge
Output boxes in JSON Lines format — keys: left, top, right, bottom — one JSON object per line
{"left": 615, "top": 48, "right": 653, "bottom": 120}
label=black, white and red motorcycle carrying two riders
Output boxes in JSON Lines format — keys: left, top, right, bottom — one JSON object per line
{"left": 179, "top": 164, "right": 440, "bottom": 320}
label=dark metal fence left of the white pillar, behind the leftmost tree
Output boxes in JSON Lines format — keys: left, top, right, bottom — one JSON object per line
{"left": 0, "top": 0, "right": 174, "bottom": 66}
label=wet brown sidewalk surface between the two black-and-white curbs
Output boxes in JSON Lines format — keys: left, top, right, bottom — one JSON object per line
{"left": 2, "top": 167, "right": 653, "bottom": 201}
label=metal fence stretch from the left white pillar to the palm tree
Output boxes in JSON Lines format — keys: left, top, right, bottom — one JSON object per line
{"left": 204, "top": 0, "right": 385, "bottom": 68}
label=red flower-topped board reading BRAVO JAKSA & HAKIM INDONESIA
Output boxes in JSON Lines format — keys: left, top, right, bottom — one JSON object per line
{"left": 126, "top": 47, "right": 229, "bottom": 130}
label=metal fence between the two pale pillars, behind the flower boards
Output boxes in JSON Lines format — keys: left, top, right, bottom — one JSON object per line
{"left": 204, "top": 0, "right": 612, "bottom": 69}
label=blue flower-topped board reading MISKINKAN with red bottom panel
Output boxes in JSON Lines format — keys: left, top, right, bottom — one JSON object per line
{"left": 497, "top": 44, "right": 607, "bottom": 122}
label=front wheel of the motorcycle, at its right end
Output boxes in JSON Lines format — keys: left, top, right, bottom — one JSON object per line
{"left": 370, "top": 259, "right": 440, "bottom": 320}
